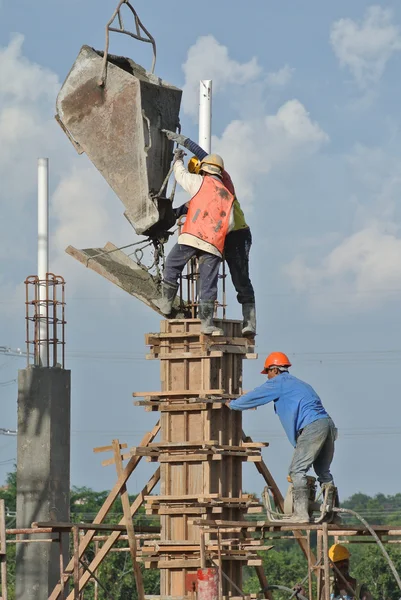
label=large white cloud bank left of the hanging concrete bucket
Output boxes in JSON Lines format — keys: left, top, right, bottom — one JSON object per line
{"left": 0, "top": 34, "right": 128, "bottom": 296}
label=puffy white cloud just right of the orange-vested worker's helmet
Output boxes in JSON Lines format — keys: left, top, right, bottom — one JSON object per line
{"left": 213, "top": 100, "right": 329, "bottom": 205}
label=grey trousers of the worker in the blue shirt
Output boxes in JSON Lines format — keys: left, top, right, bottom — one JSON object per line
{"left": 289, "top": 417, "right": 336, "bottom": 489}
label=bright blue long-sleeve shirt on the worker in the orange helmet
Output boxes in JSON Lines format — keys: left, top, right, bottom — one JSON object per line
{"left": 230, "top": 372, "right": 329, "bottom": 447}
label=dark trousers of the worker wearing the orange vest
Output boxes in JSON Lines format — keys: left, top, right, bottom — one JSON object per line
{"left": 163, "top": 244, "right": 221, "bottom": 302}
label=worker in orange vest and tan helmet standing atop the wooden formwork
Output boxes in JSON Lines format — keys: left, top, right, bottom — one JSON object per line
{"left": 159, "top": 150, "right": 234, "bottom": 335}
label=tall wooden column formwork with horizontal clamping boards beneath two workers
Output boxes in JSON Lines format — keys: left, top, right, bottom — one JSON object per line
{"left": 138, "top": 319, "right": 256, "bottom": 598}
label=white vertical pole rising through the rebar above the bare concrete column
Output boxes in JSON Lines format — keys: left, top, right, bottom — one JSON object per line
{"left": 38, "top": 158, "right": 49, "bottom": 367}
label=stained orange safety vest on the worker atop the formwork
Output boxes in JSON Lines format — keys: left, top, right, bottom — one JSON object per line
{"left": 181, "top": 175, "right": 234, "bottom": 254}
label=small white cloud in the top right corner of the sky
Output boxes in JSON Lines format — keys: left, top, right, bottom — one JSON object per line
{"left": 330, "top": 6, "right": 401, "bottom": 89}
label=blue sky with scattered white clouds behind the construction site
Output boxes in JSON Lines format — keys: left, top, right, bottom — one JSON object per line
{"left": 0, "top": 0, "right": 401, "bottom": 498}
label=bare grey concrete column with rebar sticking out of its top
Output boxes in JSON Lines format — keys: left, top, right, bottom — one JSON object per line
{"left": 16, "top": 366, "right": 71, "bottom": 600}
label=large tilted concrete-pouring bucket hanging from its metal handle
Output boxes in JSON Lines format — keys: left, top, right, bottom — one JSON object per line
{"left": 56, "top": 0, "right": 182, "bottom": 237}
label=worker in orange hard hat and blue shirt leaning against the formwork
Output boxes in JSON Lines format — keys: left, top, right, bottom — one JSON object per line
{"left": 227, "top": 352, "right": 337, "bottom": 523}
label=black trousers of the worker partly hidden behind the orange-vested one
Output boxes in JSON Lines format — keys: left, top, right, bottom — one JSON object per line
{"left": 224, "top": 228, "right": 255, "bottom": 304}
